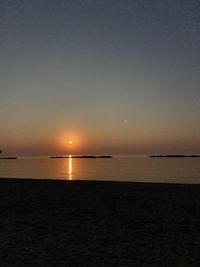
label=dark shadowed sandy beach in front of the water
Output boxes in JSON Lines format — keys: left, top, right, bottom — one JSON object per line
{"left": 0, "top": 179, "right": 200, "bottom": 267}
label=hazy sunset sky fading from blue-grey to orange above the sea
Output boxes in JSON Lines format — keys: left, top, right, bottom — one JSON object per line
{"left": 0, "top": 0, "right": 200, "bottom": 155}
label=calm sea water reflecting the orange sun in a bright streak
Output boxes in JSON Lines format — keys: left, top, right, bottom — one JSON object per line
{"left": 0, "top": 157, "right": 200, "bottom": 183}
